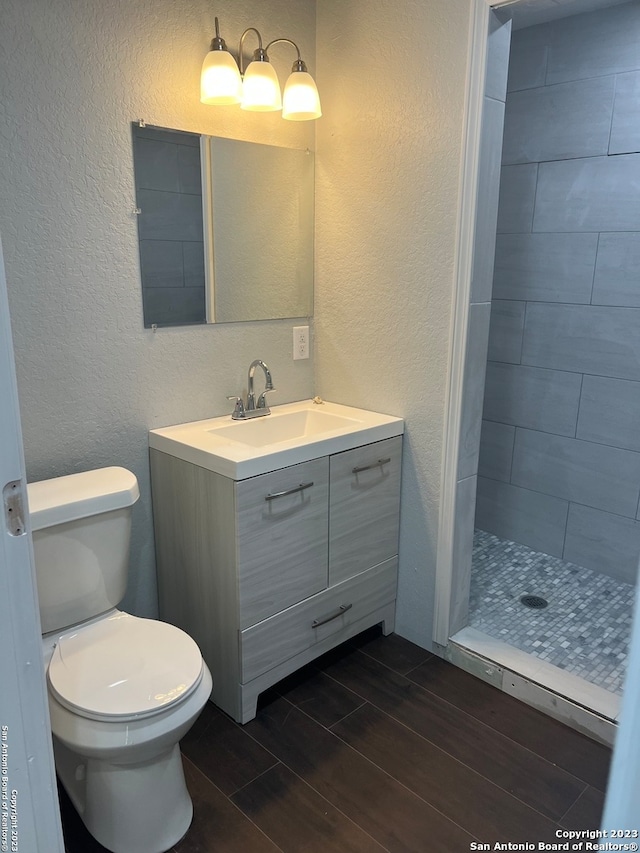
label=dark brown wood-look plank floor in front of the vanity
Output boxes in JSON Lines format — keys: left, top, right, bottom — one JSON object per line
{"left": 61, "top": 630, "right": 610, "bottom": 853}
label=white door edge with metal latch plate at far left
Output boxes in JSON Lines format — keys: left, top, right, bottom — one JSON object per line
{"left": 0, "top": 238, "right": 64, "bottom": 853}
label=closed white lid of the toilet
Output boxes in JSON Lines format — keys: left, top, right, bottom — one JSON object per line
{"left": 47, "top": 612, "right": 203, "bottom": 720}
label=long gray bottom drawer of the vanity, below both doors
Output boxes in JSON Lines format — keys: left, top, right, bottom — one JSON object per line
{"left": 240, "top": 557, "right": 398, "bottom": 683}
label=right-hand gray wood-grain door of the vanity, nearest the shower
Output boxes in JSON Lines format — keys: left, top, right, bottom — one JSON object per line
{"left": 329, "top": 436, "right": 402, "bottom": 585}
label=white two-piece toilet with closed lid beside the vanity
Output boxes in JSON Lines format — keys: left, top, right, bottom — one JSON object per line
{"left": 27, "top": 467, "right": 212, "bottom": 853}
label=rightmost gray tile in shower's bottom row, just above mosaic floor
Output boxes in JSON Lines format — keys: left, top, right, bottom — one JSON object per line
{"left": 564, "top": 504, "right": 640, "bottom": 586}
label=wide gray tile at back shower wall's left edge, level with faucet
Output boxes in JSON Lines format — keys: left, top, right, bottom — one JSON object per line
{"left": 484, "top": 362, "right": 581, "bottom": 436}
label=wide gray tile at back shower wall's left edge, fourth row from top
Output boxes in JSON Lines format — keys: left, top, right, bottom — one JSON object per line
{"left": 493, "top": 234, "right": 596, "bottom": 304}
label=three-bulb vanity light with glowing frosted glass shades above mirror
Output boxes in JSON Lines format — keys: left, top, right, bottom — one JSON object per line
{"left": 200, "top": 18, "right": 322, "bottom": 121}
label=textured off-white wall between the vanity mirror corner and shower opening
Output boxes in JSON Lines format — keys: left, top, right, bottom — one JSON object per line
{"left": 315, "top": 0, "right": 470, "bottom": 647}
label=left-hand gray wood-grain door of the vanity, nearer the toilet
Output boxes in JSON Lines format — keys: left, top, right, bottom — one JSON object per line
{"left": 236, "top": 458, "right": 329, "bottom": 628}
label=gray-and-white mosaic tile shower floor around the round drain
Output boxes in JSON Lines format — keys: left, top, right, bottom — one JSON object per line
{"left": 469, "top": 530, "right": 634, "bottom": 694}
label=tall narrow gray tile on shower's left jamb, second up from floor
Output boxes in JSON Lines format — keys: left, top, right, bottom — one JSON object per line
{"left": 458, "top": 302, "right": 491, "bottom": 480}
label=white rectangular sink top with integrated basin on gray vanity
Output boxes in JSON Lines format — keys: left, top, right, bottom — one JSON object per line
{"left": 149, "top": 400, "right": 404, "bottom": 480}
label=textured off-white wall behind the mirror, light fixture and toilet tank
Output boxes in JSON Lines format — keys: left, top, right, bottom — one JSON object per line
{"left": 0, "top": 0, "right": 315, "bottom": 615}
